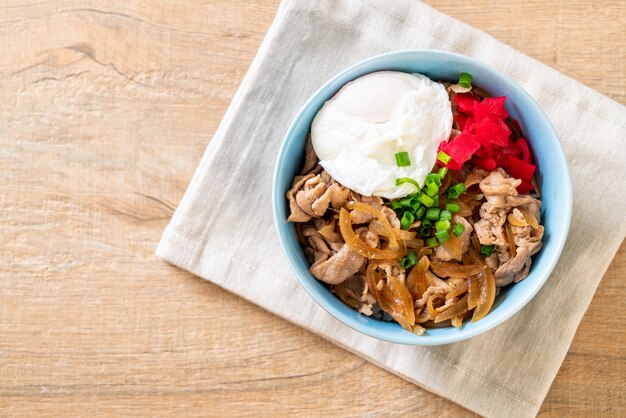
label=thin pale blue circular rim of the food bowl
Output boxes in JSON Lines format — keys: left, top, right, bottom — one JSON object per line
{"left": 272, "top": 49, "right": 573, "bottom": 346}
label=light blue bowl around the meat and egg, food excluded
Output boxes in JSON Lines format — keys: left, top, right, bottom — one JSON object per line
{"left": 272, "top": 50, "right": 572, "bottom": 345}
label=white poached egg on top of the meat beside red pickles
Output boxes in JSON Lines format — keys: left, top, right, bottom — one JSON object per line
{"left": 311, "top": 71, "right": 452, "bottom": 199}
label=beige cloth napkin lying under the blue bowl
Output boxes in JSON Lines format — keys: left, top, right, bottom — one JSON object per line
{"left": 157, "top": 0, "right": 626, "bottom": 417}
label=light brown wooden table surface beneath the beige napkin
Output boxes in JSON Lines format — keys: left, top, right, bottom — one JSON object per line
{"left": 0, "top": 0, "right": 626, "bottom": 416}
